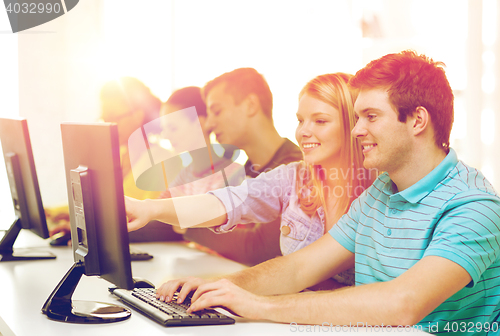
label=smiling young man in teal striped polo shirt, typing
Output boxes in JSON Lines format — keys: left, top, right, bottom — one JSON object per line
{"left": 154, "top": 51, "right": 500, "bottom": 335}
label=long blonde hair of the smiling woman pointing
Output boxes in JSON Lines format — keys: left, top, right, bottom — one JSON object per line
{"left": 296, "top": 72, "right": 373, "bottom": 219}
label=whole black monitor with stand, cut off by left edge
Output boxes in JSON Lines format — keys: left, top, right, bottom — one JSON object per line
{"left": 0, "top": 118, "right": 55, "bottom": 262}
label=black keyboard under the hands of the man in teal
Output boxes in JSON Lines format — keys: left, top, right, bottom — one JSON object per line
{"left": 112, "top": 288, "right": 234, "bottom": 326}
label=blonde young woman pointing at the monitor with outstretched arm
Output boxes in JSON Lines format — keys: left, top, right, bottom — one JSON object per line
{"left": 126, "top": 73, "right": 375, "bottom": 285}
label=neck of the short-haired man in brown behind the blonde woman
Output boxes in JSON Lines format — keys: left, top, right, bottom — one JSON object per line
{"left": 243, "top": 127, "right": 285, "bottom": 170}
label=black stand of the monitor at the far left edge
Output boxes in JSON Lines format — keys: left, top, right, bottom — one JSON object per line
{"left": 0, "top": 218, "right": 56, "bottom": 262}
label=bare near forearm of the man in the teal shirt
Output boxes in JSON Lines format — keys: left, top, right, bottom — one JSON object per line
{"left": 258, "top": 256, "right": 471, "bottom": 326}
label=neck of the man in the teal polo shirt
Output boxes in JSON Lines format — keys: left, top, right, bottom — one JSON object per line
{"left": 389, "top": 146, "right": 447, "bottom": 191}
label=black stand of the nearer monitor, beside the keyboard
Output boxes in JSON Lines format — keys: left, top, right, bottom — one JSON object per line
{"left": 42, "top": 262, "right": 131, "bottom": 324}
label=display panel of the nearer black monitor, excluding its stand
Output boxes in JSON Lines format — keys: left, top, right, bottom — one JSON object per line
{"left": 61, "top": 123, "right": 134, "bottom": 289}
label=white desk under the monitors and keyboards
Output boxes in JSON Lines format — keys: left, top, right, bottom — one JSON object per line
{"left": 0, "top": 230, "right": 426, "bottom": 336}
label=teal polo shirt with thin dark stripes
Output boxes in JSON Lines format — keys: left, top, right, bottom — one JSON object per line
{"left": 330, "top": 149, "right": 500, "bottom": 335}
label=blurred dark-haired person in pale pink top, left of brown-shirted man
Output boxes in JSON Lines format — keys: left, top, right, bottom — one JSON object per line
{"left": 160, "top": 86, "right": 245, "bottom": 198}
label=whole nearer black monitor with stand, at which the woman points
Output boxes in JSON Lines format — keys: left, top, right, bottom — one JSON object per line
{"left": 42, "top": 123, "right": 153, "bottom": 323}
